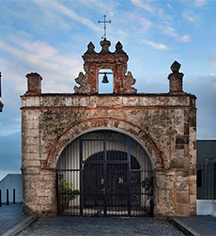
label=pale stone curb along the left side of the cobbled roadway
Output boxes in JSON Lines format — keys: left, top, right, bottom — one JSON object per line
{"left": 2, "top": 215, "right": 38, "bottom": 236}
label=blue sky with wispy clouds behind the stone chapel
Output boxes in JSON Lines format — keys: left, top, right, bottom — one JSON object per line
{"left": 0, "top": 0, "right": 216, "bottom": 179}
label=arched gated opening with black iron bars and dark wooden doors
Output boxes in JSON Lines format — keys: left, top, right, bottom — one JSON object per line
{"left": 57, "top": 130, "right": 153, "bottom": 216}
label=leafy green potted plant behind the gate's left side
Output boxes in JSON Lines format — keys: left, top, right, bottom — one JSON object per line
{"left": 59, "top": 179, "right": 79, "bottom": 202}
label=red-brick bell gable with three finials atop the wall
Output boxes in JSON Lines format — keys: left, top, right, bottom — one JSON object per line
{"left": 74, "top": 39, "right": 137, "bottom": 94}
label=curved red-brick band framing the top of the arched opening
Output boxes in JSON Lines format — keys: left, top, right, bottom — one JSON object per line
{"left": 44, "top": 118, "right": 165, "bottom": 169}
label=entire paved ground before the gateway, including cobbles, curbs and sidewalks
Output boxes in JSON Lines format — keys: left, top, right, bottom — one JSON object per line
{"left": 0, "top": 203, "right": 216, "bottom": 236}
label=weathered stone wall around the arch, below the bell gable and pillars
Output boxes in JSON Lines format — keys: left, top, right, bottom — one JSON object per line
{"left": 21, "top": 93, "right": 196, "bottom": 217}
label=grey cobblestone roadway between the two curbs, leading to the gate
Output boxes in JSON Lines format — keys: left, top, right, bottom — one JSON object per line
{"left": 18, "top": 216, "right": 184, "bottom": 236}
